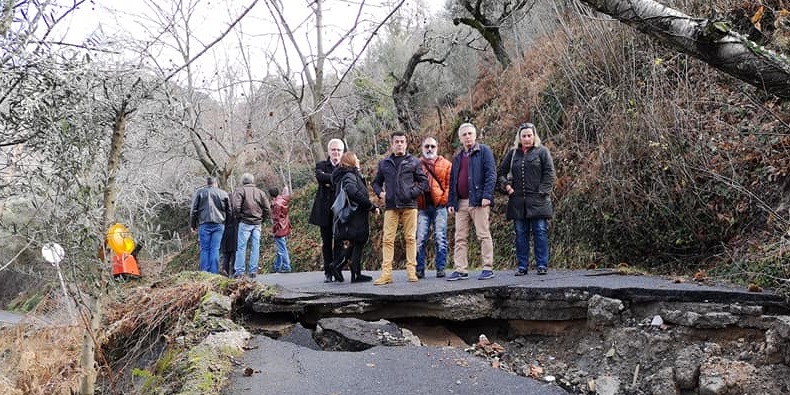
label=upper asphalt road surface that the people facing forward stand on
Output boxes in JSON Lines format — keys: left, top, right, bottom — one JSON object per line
{"left": 256, "top": 269, "right": 786, "bottom": 306}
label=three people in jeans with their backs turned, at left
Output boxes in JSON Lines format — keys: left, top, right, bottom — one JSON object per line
{"left": 190, "top": 173, "right": 291, "bottom": 278}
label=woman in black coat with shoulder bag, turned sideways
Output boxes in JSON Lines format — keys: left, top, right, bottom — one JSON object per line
{"left": 332, "top": 151, "right": 378, "bottom": 283}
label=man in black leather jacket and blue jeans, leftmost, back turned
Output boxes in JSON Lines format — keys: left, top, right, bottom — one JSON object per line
{"left": 189, "top": 177, "right": 230, "bottom": 274}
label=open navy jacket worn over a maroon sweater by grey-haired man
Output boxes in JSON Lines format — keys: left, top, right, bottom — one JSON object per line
{"left": 447, "top": 144, "right": 496, "bottom": 210}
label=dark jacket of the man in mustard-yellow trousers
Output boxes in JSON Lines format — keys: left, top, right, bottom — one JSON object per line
{"left": 372, "top": 154, "right": 428, "bottom": 210}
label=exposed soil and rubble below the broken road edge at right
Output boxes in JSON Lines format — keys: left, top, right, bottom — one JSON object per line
{"left": 402, "top": 319, "right": 790, "bottom": 394}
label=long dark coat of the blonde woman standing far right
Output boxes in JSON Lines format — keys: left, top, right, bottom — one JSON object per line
{"left": 498, "top": 145, "right": 557, "bottom": 219}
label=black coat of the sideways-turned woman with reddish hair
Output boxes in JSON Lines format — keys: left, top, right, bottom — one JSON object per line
{"left": 332, "top": 166, "right": 376, "bottom": 244}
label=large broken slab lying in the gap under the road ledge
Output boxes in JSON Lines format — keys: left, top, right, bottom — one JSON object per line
{"left": 313, "top": 317, "right": 409, "bottom": 351}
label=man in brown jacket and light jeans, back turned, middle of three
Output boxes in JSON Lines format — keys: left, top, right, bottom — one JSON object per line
{"left": 231, "top": 173, "right": 270, "bottom": 278}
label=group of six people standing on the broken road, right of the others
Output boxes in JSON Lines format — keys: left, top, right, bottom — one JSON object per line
{"left": 310, "top": 123, "right": 556, "bottom": 285}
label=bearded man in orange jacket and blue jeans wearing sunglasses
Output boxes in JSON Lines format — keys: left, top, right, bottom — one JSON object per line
{"left": 417, "top": 137, "right": 453, "bottom": 278}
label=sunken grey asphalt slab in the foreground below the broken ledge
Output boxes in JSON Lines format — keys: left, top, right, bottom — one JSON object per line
{"left": 224, "top": 336, "right": 567, "bottom": 395}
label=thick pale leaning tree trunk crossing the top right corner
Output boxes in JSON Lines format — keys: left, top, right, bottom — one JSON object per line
{"left": 582, "top": 0, "right": 790, "bottom": 98}
